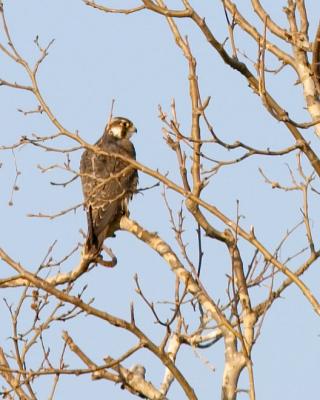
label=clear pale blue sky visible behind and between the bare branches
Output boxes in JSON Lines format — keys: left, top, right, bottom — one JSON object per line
{"left": 0, "top": 0, "right": 320, "bottom": 400}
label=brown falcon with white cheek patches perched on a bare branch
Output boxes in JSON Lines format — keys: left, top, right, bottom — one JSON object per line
{"left": 80, "top": 117, "right": 138, "bottom": 254}
